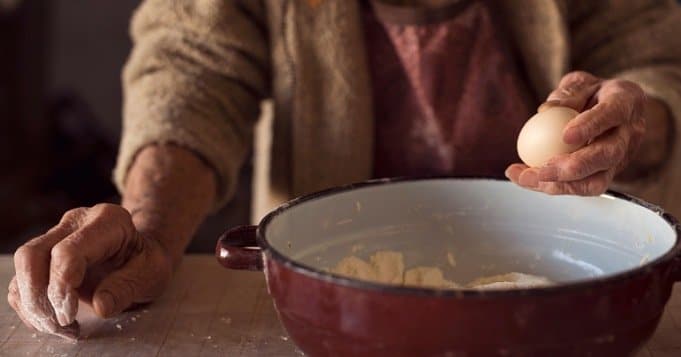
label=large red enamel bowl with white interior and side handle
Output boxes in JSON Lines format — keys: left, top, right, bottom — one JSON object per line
{"left": 216, "top": 178, "right": 681, "bottom": 356}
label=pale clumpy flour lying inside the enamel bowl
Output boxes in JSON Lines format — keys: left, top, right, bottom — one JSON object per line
{"left": 331, "top": 251, "right": 553, "bottom": 290}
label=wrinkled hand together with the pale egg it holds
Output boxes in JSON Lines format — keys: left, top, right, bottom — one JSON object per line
{"left": 506, "top": 72, "right": 646, "bottom": 196}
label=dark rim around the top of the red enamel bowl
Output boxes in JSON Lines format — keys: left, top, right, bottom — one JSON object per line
{"left": 256, "top": 175, "right": 681, "bottom": 298}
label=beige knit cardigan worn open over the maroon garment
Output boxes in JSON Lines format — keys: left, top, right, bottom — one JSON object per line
{"left": 114, "top": 0, "right": 681, "bottom": 216}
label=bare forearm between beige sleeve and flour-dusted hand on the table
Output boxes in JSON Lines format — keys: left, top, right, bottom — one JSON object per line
{"left": 122, "top": 145, "right": 216, "bottom": 267}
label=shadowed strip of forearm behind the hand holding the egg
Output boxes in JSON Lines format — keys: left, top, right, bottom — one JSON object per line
{"left": 618, "top": 98, "right": 674, "bottom": 181}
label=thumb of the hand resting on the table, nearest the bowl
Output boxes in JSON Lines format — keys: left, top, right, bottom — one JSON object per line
{"left": 92, "top": 242, "right": 172, "bottom": 318}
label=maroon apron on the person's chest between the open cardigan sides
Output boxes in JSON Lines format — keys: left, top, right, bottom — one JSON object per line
{"left": 364, "top": 1, "right": 534, "bottom": 177}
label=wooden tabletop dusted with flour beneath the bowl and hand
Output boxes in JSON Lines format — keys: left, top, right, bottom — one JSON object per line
{"left": 0, "top": 255, "right": 681, "bottom": 357}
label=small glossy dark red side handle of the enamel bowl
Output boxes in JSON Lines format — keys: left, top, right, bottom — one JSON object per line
{"left": 215, "top": 226, "right": 263, "bottom": 271}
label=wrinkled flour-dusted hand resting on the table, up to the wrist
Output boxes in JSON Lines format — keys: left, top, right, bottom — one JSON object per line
{"left": 7, "top": 204, "right": 172, "bottom": 338}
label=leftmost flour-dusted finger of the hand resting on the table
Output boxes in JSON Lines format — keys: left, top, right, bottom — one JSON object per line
{"left": 14, "top": 217, "right": 78, "bottom": 333}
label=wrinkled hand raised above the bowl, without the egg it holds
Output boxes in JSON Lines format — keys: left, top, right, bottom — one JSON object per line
{"left": 506, "top": 72, "right": 646, "bottom": 196}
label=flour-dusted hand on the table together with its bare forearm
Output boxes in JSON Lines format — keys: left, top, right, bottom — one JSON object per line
{"left": 7, "top": 145, "right": 216, "bottom": 338}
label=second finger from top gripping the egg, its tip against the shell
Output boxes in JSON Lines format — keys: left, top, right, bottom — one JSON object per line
{"left": 563, "top": 102, "right": 629, "bottom": 145}
